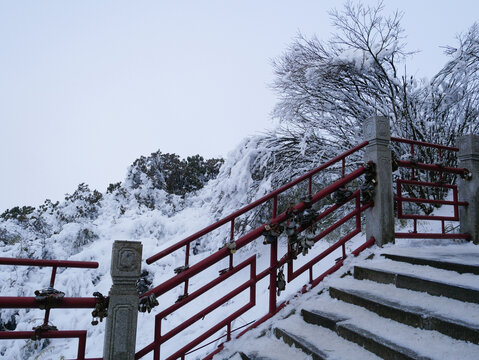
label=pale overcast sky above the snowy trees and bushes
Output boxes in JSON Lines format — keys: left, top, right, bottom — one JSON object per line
{"left": 0, "top": 0, "right": 479, "bottom": 212}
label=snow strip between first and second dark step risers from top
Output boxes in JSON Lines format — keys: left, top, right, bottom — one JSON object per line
{"left": 360, "top": 256, "right": 479, "bottom": 291}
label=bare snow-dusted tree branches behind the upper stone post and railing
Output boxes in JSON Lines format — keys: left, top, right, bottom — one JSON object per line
{"left": 269, "top": 2, "right": 479, "bottom": 208}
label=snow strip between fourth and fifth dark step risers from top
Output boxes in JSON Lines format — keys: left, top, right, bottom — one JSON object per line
{"left": 274, "top": 314, "right": 380, "bottom": 360}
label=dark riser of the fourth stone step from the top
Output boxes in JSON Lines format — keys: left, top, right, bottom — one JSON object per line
{"left": 301, "top": 309, "right": 429, "bottom": 360}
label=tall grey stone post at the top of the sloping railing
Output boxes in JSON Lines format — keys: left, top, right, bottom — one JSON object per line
{"left": 363, "top": 116, "right": 394, "bottom": 246}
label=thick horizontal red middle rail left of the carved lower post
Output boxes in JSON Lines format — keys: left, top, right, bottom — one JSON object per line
{"left": 0, "top": 296, "right": 97, "bottom": 309}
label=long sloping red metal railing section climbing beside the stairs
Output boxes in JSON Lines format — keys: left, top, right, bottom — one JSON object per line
{"left": 135, "top": 142, "right": 374, "bottom": 360}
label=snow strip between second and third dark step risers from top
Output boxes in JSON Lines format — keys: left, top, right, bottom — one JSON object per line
{"left": 331, "top": 277, "right": 479, "bottom": 326}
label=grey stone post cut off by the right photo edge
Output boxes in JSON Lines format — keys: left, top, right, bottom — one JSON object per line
{"left": 457, "top": 134, "right": 479, "bottom": 244}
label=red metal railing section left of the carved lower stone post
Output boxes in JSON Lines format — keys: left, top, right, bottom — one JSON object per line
{"left": 0, "top": 258, "right": 101, "bottom": 360}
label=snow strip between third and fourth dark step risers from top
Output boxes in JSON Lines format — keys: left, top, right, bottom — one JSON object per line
{"left": 297, "top": 294, "right": 479, "bottom": 360}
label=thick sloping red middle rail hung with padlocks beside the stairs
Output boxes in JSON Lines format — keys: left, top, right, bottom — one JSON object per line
{"left": 141, "top": 166, "right": 365, "bottom": 298}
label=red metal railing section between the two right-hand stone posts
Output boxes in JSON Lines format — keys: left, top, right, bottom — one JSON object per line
{"left": 391, "top": 137, "right": 469, "bottom": 239}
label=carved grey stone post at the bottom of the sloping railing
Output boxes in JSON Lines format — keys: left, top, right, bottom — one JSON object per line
{"left": 103, "top": 241, "right": 142, "bottom": 360}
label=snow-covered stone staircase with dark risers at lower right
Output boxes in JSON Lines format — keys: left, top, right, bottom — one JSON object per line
{"left": 223, "top": 245, "right": 479, "bottom": 360}
